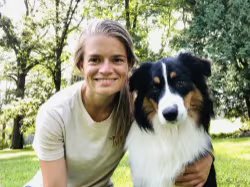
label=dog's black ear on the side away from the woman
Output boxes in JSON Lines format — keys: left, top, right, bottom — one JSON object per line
{"left": 178, "top": 53, "right": 211, "bottom": 77}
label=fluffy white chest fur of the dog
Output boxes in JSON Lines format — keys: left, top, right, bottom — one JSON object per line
{"left": 126, "top": 119, "right": 210, "bottom": 187}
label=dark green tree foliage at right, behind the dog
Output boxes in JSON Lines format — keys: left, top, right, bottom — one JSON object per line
{"left": 172, "top": 0, "right": 250, "bottom": 117}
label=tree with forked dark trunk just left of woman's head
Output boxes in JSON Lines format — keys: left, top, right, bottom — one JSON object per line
{"left": 38, "top": 0, "right": 84, "bottom": 91}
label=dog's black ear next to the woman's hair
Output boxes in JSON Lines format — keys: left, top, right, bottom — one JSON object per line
{"left": 129, "top": 62, "right": 152, "bottom": 92}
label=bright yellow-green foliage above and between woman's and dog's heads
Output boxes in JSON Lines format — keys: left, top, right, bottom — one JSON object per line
{"left": 84, "top": 0, "right": 182, "bottom": 62}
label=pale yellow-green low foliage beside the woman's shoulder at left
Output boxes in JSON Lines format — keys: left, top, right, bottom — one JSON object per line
{"left": 0, "top": 62, "right": 55, "bottom": 147}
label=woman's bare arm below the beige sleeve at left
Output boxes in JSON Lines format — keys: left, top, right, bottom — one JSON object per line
{"left": 40, "top": 158, "right": 67, "bottom": 187}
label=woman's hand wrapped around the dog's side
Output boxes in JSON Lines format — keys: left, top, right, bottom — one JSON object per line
{"left": 175, "top": 154, "right": 213, "bottom": 187}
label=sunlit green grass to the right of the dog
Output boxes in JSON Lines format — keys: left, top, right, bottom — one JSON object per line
{"left": 213, "top": 138, "right": 250, "bottom": 187}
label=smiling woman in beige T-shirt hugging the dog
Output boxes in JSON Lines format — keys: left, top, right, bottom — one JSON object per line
{"left": 27, "top": 20, "right": 212, "bottom": 187}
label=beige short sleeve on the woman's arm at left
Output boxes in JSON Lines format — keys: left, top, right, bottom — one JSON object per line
{"left": 33, "top": 107, "right": 64, "bottom": 161}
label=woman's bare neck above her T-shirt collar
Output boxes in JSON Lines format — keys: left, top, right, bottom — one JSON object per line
{"left": 81, "top": 86, "right": 115, "bottom": 122}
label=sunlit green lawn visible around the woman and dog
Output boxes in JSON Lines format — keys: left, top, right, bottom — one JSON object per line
{"left": 0, "top": 138, "right": 250, "bottom": 187}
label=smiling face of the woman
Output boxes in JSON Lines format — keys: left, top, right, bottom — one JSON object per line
{"left": 81, "top": 35, "right": 129, "bottom": 96}
